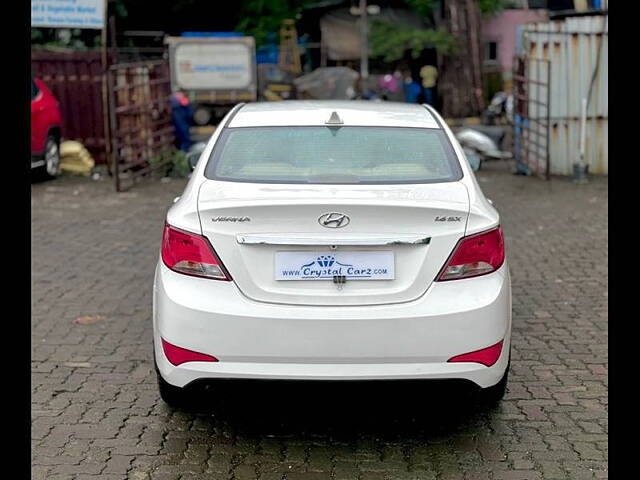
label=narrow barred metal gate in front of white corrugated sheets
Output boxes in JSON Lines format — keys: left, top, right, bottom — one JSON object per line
{"left": 513, "top": 55, "right": 551, "bottom": 180}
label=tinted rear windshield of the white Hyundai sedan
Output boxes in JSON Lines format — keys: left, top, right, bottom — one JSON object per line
{"left": 205, "top": 126, "right": 462, "bottom": 184}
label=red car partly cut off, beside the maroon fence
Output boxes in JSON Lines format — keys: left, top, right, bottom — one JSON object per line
{"left": 31, "top": 78, "right": 62, "bottom": 178}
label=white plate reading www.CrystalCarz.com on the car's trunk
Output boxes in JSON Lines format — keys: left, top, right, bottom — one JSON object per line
{"left": 274, "top": 250, "right": 395, "bottom": 281}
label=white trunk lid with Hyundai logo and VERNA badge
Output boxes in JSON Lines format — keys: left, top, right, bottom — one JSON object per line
{"left": 198, "top": 180, "right": 469, "bottom": 306}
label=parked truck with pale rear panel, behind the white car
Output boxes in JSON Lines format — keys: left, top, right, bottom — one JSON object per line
{"left": 165, "top": 34, "right": 257, "bottom": 125}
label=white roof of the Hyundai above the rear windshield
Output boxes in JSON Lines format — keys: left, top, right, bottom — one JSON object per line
{"left": 227, "top": 100, "right": 441, "bottom": 129}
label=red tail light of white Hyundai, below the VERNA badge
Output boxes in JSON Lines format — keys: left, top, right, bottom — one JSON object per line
{"left": 162, "top": 224, "right": 231, "bottom": 280}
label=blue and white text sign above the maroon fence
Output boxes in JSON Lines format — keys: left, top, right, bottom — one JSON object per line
{"left": 31, "top": 0, "right": 105, "bottom": 29}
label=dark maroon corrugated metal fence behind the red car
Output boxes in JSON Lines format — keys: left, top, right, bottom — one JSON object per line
{"left": 31, "top": 50, "right": 107, "bottom": 164}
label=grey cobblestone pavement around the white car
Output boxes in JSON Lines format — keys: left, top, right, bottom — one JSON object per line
{"left": 31, "top": 165, "right": 608, "bottom": 480}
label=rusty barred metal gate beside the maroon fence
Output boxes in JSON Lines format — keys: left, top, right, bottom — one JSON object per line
{"left": 108, "top": 60, "right": 175, "bottom": 192}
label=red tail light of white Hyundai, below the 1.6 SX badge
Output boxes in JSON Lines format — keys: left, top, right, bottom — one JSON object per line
{"left": 437, "top": 227, "right": 504, "bottom": 281}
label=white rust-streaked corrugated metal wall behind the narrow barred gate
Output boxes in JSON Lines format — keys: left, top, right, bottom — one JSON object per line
{"left": 523, "top": 13, "right": 609, "bottom": 175}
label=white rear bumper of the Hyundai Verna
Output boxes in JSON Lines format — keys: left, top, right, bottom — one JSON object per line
{"left": 153, "top": 263, "right": 511, "bottom": 387}
